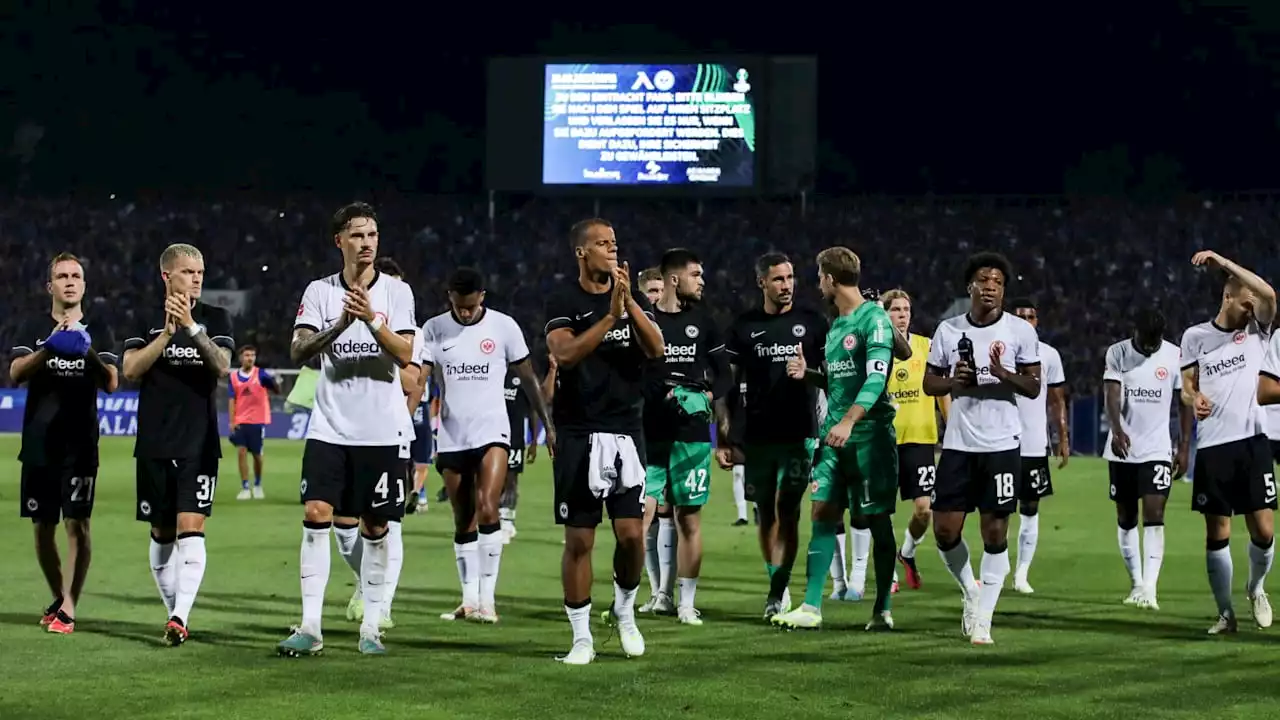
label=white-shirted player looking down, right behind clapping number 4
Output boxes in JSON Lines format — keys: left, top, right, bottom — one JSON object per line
{"left": 422, "top": 268, "right": 556, "bottom": 623}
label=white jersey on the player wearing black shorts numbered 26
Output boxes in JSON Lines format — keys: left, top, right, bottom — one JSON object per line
{"left": 1102, "top": 340, "right": 1183, "bottom": 464}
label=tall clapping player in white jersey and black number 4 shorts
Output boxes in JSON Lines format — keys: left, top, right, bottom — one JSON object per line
{"left": 276, "top": 202, "right": 417, "bottom": 657}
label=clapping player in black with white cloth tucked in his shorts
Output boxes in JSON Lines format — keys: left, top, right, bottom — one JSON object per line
{"left": 547, "top": 218, "right": 663, "bottom": 665}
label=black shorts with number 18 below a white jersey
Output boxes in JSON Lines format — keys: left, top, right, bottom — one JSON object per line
{"left": 933, "top": 448, "right": 1021, "bottom": 515}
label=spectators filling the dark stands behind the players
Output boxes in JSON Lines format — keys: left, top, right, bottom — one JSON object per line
{"left": 0, "top": 195, "right": 1280, "bottom": 396}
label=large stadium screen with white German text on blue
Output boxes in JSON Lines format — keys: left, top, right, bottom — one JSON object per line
{"left": 486, "top": 56, "right": 817, "bottom": 195}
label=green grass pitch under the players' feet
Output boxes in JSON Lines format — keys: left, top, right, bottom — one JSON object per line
{"left": 0, "top": 436, "right": 1280, "bottom": 720}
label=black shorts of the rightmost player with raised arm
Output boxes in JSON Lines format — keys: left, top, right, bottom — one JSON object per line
{"left": 1192, "top": 436, "right": 1276, "bottom": 518}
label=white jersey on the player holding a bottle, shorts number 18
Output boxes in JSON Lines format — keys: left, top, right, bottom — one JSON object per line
{"left": 928, "top": 313, "right": 1039, "bottom": 452}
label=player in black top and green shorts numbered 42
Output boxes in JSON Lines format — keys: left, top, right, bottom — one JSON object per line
{"left": 644, "top": 249, "right": 732, "bottom": 625}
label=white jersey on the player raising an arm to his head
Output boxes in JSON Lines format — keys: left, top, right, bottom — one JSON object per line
{"left": 1183, "top": 316, "right": 1267, "bottom": 447}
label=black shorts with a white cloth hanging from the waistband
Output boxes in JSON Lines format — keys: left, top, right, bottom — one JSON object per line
{"left": 554, "top": 432, "right": 645, "bottom": 528}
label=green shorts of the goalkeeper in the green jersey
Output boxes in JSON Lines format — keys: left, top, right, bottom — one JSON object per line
{"left": 810, "top": 425, "right": 897, "bottom": 515}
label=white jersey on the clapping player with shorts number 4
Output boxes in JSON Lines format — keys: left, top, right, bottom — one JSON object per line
{"left": 293, "top": 273, "right": 415, "bottom": 446}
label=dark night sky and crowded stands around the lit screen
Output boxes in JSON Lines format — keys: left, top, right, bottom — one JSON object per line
{"left": 0, "top": 3, "right": 1280, "bottom": 409}
